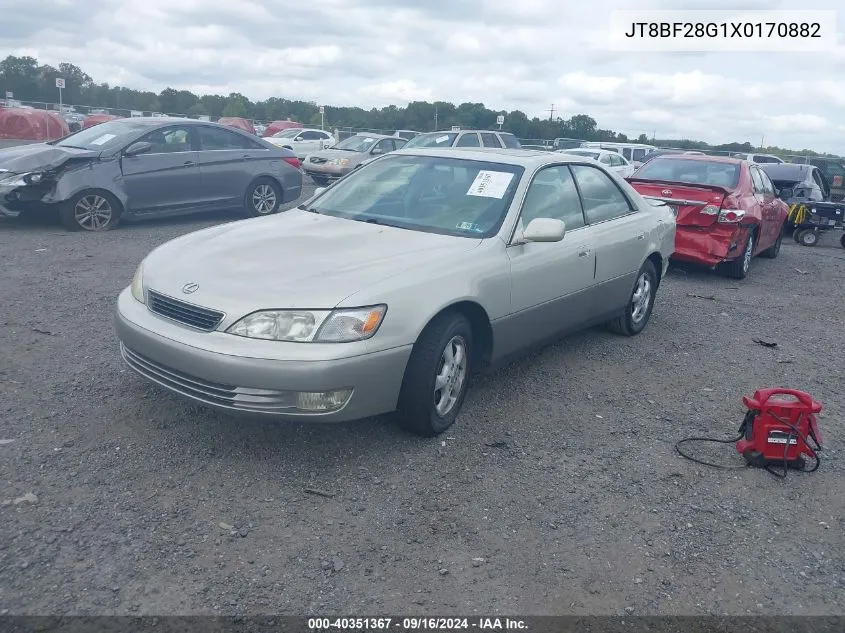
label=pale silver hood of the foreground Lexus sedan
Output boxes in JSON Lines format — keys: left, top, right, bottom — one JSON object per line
{"left": 143, "top": 209, "right": 482, "bottom": 321}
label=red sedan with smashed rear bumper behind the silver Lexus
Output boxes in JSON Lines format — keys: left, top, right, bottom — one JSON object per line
{"left": 627, "top": 154, "right": 789, "bottom": 279}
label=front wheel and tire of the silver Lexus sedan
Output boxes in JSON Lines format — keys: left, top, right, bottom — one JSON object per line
{"left": 395, "top": 313, "right": 473, "bottom": 437}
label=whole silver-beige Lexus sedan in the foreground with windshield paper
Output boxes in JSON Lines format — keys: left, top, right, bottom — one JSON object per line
{"left": 115, "top": 149, "right": 675, "bottom": 436}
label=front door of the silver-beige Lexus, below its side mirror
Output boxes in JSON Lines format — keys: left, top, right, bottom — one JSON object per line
{"left": 496, "top": 165, "right": 596, "bottom": 355}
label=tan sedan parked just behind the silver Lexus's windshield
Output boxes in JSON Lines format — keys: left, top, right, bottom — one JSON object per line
{"left": 302, "top": 134, "right": 407, "bottom": 186}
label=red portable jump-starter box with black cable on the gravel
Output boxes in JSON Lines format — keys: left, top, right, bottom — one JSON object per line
{"left": 675, "top": 387, "right": 822, "bottom": 477}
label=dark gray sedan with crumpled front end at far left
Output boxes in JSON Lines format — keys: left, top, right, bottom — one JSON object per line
{"left": 0, "top": 117, "right": 302, "bottom": 231}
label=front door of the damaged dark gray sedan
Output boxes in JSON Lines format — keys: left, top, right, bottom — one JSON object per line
{"left": 120, "top": 125, "right": 200, "bottom": 215}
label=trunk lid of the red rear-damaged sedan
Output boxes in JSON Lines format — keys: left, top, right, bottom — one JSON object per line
{"left": 627, "top": 178, "right": 731, "bottom": 226}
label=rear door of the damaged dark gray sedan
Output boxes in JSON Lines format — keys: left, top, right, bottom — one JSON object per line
{"left": 197, "top": 125, "right": 264, "bottom": 209}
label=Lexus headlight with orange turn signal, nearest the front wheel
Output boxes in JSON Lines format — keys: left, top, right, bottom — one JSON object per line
{"left": 231, "top": 305, "right": 387, "bottom": 343}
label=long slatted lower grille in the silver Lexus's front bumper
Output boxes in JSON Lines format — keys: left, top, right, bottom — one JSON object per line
{"left": 120, "top": 343, "right": 296, "bottom": 413}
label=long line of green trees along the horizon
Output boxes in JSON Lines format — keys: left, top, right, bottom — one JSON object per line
{"left": 0, "top": 55, "right": 810, "bottom": 153}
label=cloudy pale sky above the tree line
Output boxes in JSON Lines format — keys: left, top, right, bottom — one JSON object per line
{"left": 0, "top": 0, "right": 845, "bottom": 154}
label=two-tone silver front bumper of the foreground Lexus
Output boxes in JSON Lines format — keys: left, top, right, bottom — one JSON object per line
{"left": 115, "top": 289, "right": 412, "bottom": 422}
